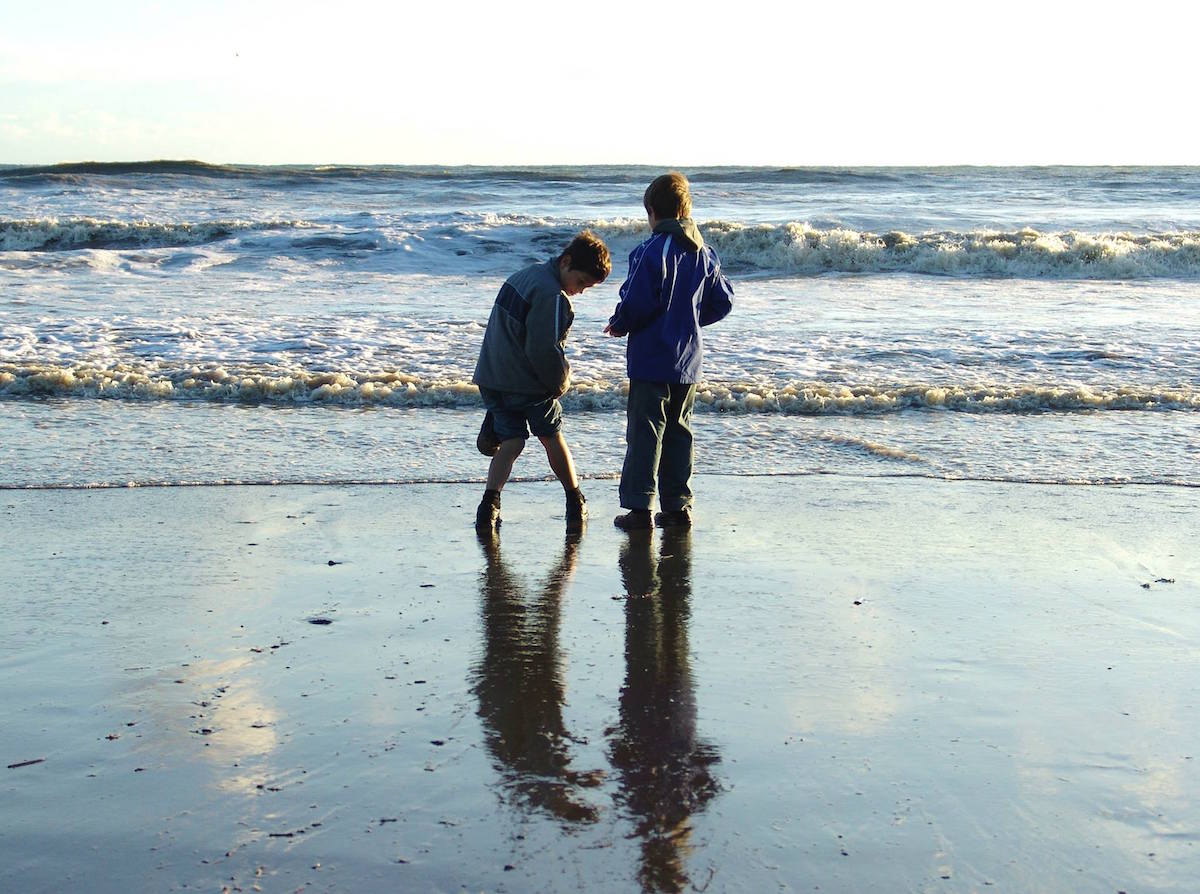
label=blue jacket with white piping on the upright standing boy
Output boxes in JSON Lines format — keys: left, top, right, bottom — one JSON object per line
{"left": 608, "top": 217, "right": 733, "bottom": 384}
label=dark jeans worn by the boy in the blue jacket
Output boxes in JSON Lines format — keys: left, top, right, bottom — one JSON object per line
{"left": 620, "top": 379, "right": 696, "bottom": 511}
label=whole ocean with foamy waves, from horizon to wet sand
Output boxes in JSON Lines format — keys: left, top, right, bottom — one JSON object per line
{"left": 0, "top": 162, "right": 1200, "bottom": 492}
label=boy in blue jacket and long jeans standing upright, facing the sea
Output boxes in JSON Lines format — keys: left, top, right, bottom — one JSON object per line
{"left": 605, "top": 172, "right": 733, "bottom": 530}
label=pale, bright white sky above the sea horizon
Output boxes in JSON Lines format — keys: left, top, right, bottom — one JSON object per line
{"left": 0, "top": 0, "right": 1200, "bottom": 166}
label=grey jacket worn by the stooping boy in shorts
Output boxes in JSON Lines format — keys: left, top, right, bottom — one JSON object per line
{"left": 472, "top": 258, "right": 575, "bottom": 397}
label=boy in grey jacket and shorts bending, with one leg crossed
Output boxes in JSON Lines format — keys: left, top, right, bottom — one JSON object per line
{"left": 472, "top": 230, "right": 612, "bottom": 535}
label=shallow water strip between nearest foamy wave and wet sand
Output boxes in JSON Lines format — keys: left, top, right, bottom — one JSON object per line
{"left": 0, "top": 400, "right": 1200, "bottom": 488}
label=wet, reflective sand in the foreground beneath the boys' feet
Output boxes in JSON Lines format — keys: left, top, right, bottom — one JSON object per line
{"left": 0, "top": 476, "right": 1200, "bottom": 894}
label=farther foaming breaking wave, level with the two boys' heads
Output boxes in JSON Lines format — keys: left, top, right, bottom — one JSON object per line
{"left": 0, "top": 214, "right": 1200, "bottom": 280}
